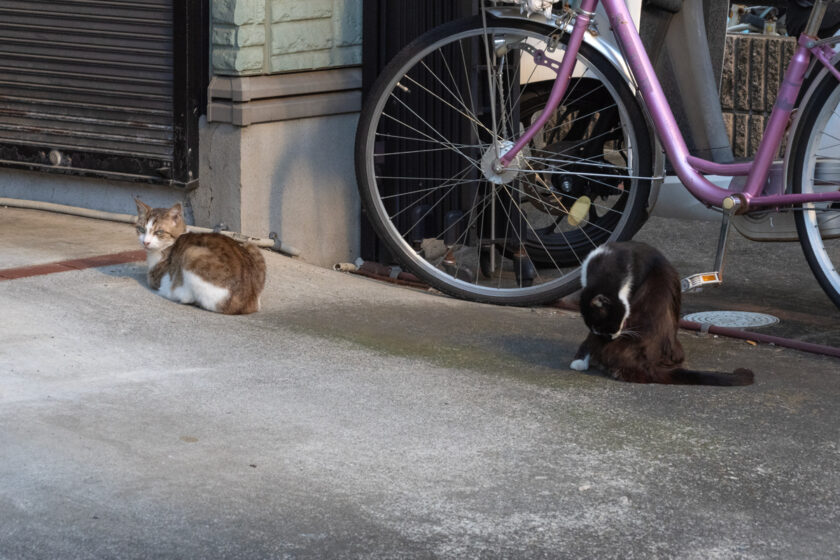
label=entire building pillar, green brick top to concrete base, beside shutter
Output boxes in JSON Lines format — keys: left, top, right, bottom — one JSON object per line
{"left": 199, "top": 0, "right": 362, "bottom": 266}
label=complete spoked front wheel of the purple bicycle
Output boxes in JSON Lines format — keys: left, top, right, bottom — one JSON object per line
{"left": 356, "top": 17, "right": 653, "bottom": 305}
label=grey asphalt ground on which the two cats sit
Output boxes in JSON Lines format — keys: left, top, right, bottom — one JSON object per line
{"left": 0, "top": 209, "right": 840, "bottom": 559}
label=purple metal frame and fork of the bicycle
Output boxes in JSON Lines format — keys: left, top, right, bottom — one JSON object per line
{"left": 500, "top": 0, "right": 840, "bottom": 212}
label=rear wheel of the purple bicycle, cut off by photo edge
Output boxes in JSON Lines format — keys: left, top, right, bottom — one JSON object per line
{"left": 792, "top": 69, "right": 840, "bottom": 307}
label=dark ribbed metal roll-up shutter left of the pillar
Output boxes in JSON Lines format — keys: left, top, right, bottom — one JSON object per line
{"left": 0, "top": 0, "right": 203, "bottom": 186}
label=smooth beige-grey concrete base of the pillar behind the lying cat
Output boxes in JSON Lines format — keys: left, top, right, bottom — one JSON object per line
{"left": 194, "top": 114, "right": 361, "bottom": 266}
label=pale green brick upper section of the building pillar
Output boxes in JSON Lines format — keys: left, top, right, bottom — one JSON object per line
{"left": 212, "top": 0, "right": 362, "bottom": 76}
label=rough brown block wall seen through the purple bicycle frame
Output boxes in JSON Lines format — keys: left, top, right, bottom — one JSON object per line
{"left": 720, "top": 34, "right": 796, "bottom": 158}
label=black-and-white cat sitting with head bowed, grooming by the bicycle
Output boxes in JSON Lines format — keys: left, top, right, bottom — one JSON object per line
{"left": 570, "top": 241, "right": 753, "bottom": 385}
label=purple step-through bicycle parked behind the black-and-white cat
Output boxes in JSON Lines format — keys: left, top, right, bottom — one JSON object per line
{"left": 356, "top": 0, "right": 840, "bottom": 307}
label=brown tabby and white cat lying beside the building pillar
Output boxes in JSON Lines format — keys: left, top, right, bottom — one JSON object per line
{"left": 135, "top": 199, "right": 265, "bottom": 315}
